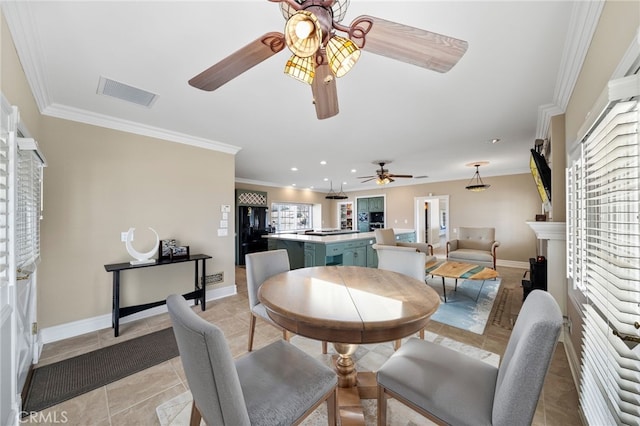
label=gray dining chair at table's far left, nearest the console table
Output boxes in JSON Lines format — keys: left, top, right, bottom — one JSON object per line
{"left": 245, "top": 249, "right": 327, "bottom": 354}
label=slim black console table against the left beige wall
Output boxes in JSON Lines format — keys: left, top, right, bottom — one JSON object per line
{"left": 104, "top": 254, "right": 211, "bottom": 337}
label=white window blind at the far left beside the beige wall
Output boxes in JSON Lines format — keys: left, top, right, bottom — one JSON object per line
{"left": 16, "top": 144, "right": 43, "bottom": 279}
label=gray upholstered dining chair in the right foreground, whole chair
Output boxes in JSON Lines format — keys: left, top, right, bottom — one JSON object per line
{"left": 377, "top": 290, "right": 562, "bottom": 426}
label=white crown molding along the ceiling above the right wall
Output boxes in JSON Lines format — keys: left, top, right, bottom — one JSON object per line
{"left": 536, "top": 0, "right": 605, "bottom": 139}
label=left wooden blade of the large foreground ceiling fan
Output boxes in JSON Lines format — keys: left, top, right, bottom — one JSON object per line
{"left": 189, "top": 32, "right": 285, "bottom": 92}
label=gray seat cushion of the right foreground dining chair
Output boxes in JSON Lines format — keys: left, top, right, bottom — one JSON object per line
{"left": 377, "top": 338, "right": 498, "bottom": 426}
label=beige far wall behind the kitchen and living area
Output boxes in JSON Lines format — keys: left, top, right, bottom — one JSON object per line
{"left": 242, "top": 172, "right": 541, "bottom": 262}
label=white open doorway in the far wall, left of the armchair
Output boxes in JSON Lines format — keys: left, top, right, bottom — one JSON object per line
{"left": 415, "top": 195, "right": 449, "bottom": 251}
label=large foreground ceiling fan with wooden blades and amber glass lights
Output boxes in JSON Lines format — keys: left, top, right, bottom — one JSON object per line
{"left": 189, "top": 0, "right": 468, "bottom": 119}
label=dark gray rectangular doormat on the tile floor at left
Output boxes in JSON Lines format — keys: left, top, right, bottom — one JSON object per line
{"left": 22, "top": 328, "right": 179, "bottom": 413}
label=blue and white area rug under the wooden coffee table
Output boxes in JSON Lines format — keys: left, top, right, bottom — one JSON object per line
{"left": 427, "top": 277, "right": 502, "bottom": 334}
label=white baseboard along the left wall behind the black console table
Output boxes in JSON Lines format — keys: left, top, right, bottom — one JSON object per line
{"left": 37, "top": 284, "right": 237, "bottom": 348}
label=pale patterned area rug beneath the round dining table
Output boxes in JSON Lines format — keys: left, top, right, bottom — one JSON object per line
{"left": 156, "top": 331, "right": 500, "bottom": 426}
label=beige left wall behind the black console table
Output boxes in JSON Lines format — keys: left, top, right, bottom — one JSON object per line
{"left": 1, "top": 11, "right": 235, "bottom": 328}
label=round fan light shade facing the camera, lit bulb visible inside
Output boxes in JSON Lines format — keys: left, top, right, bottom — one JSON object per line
{"left": 284, "top": 10, "right": 322, "bottom": 58}
